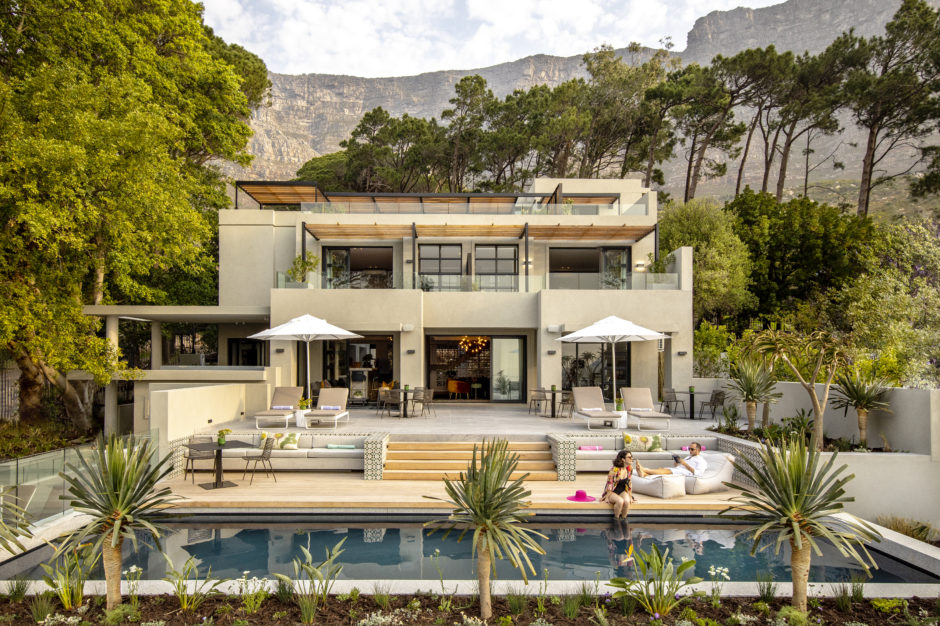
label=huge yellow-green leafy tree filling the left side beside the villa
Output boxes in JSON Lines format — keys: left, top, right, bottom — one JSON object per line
{"left": 0, "top": 0, "right": 264, "bottom": 429}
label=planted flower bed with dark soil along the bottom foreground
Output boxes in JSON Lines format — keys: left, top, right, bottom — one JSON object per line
{"left": 0, "top": 594, "right": 940, "bottom": 626}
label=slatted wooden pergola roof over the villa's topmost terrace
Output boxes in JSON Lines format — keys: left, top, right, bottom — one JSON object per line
{"left": 235, "top": 180, "right": 620, "bottom": 207}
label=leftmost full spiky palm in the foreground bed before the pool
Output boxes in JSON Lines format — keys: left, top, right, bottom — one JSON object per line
{"left": 59, "top": 435, "right": 176, "bottom": 610}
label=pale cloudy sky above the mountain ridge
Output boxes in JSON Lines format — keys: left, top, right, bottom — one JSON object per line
{"left": 202, "top": 0, "right": 783, "bottom": 78}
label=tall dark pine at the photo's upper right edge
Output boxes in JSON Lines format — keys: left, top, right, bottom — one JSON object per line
{"left": 844, "top": 0, "right": 940, "bottom": 215}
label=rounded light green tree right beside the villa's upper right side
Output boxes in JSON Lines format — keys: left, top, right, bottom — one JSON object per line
{"left": 659, "top": 200, "right": 753, "bottom": 324}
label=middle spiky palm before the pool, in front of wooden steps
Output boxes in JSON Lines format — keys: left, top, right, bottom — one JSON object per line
{"left": 425, "top": 439, "right": 546, "bottom": 619}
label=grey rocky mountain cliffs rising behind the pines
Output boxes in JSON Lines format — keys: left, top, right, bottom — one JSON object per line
{"left": 229, "top": 0, "right": 940, "bottom": 194}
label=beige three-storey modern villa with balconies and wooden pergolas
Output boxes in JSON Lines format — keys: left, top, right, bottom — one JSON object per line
{"left": 85, "top": 179, "right": 693, "bottom": 439}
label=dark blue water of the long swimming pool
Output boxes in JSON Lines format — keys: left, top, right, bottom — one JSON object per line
{"left": 0, "top": 522, "right": 940, "bottom": 583}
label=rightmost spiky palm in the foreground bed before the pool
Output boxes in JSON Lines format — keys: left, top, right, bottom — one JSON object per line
{"left": 719, "top": 435, "right": 881, "bottom": 611}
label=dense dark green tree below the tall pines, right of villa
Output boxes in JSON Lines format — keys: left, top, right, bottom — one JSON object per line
{"left": 725, "top": 188, "right": 877, "bottom": 315}
